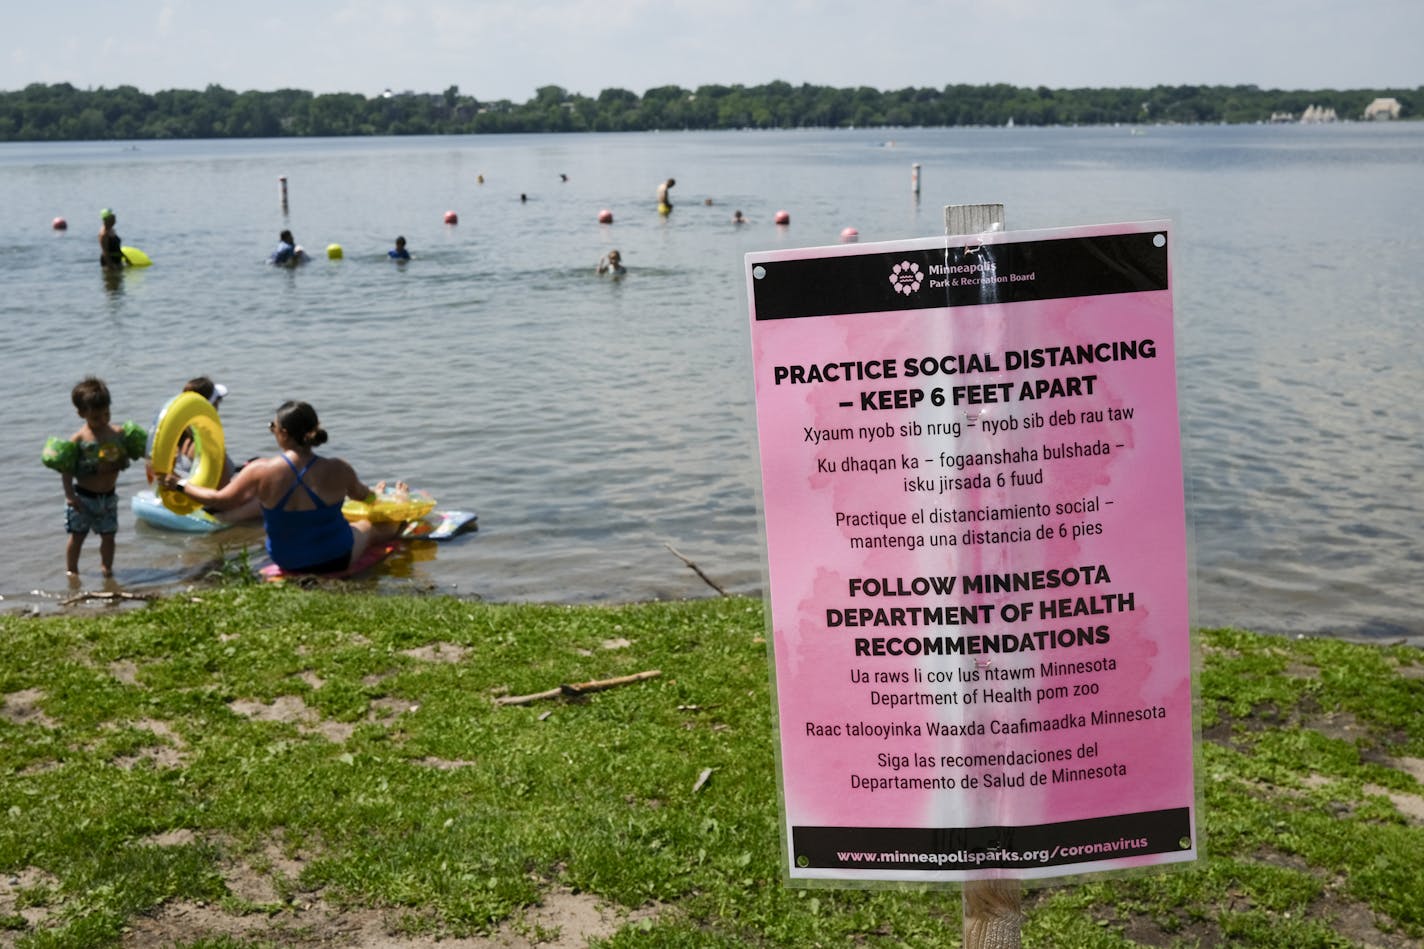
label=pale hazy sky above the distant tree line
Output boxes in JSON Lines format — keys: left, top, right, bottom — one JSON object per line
{"left": 0, "top": 0, "right": 1424, "bottom": 103}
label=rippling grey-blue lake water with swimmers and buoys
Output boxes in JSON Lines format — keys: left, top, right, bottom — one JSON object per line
{"left": 0, "top": 123, "right": 1424, "bottom": 645}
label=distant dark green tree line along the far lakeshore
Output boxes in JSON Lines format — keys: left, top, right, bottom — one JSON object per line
{"left": 0, "top": 81, "right": 1424, "bottom": 141}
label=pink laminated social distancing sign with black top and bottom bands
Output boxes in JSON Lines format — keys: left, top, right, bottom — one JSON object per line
{"left": 746, "top": 221, "right": 1198, "bottom": 882}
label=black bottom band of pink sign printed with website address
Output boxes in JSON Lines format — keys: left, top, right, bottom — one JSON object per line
{"left": 792, "top": 808, "right": 1192, "bottom": 871}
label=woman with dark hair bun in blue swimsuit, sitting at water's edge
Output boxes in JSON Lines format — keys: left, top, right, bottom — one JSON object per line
{"left": 164, "top": 402, "right": 402, "bottom": 573}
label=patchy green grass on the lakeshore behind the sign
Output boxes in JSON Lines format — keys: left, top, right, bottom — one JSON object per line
{"left": 0, "top": 586, "right": 1424, "bottom": 949}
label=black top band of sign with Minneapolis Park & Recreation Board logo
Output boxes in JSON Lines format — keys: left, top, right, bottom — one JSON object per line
{"left": 752, "top": 231, "right": 1168, "bottom": 321}
